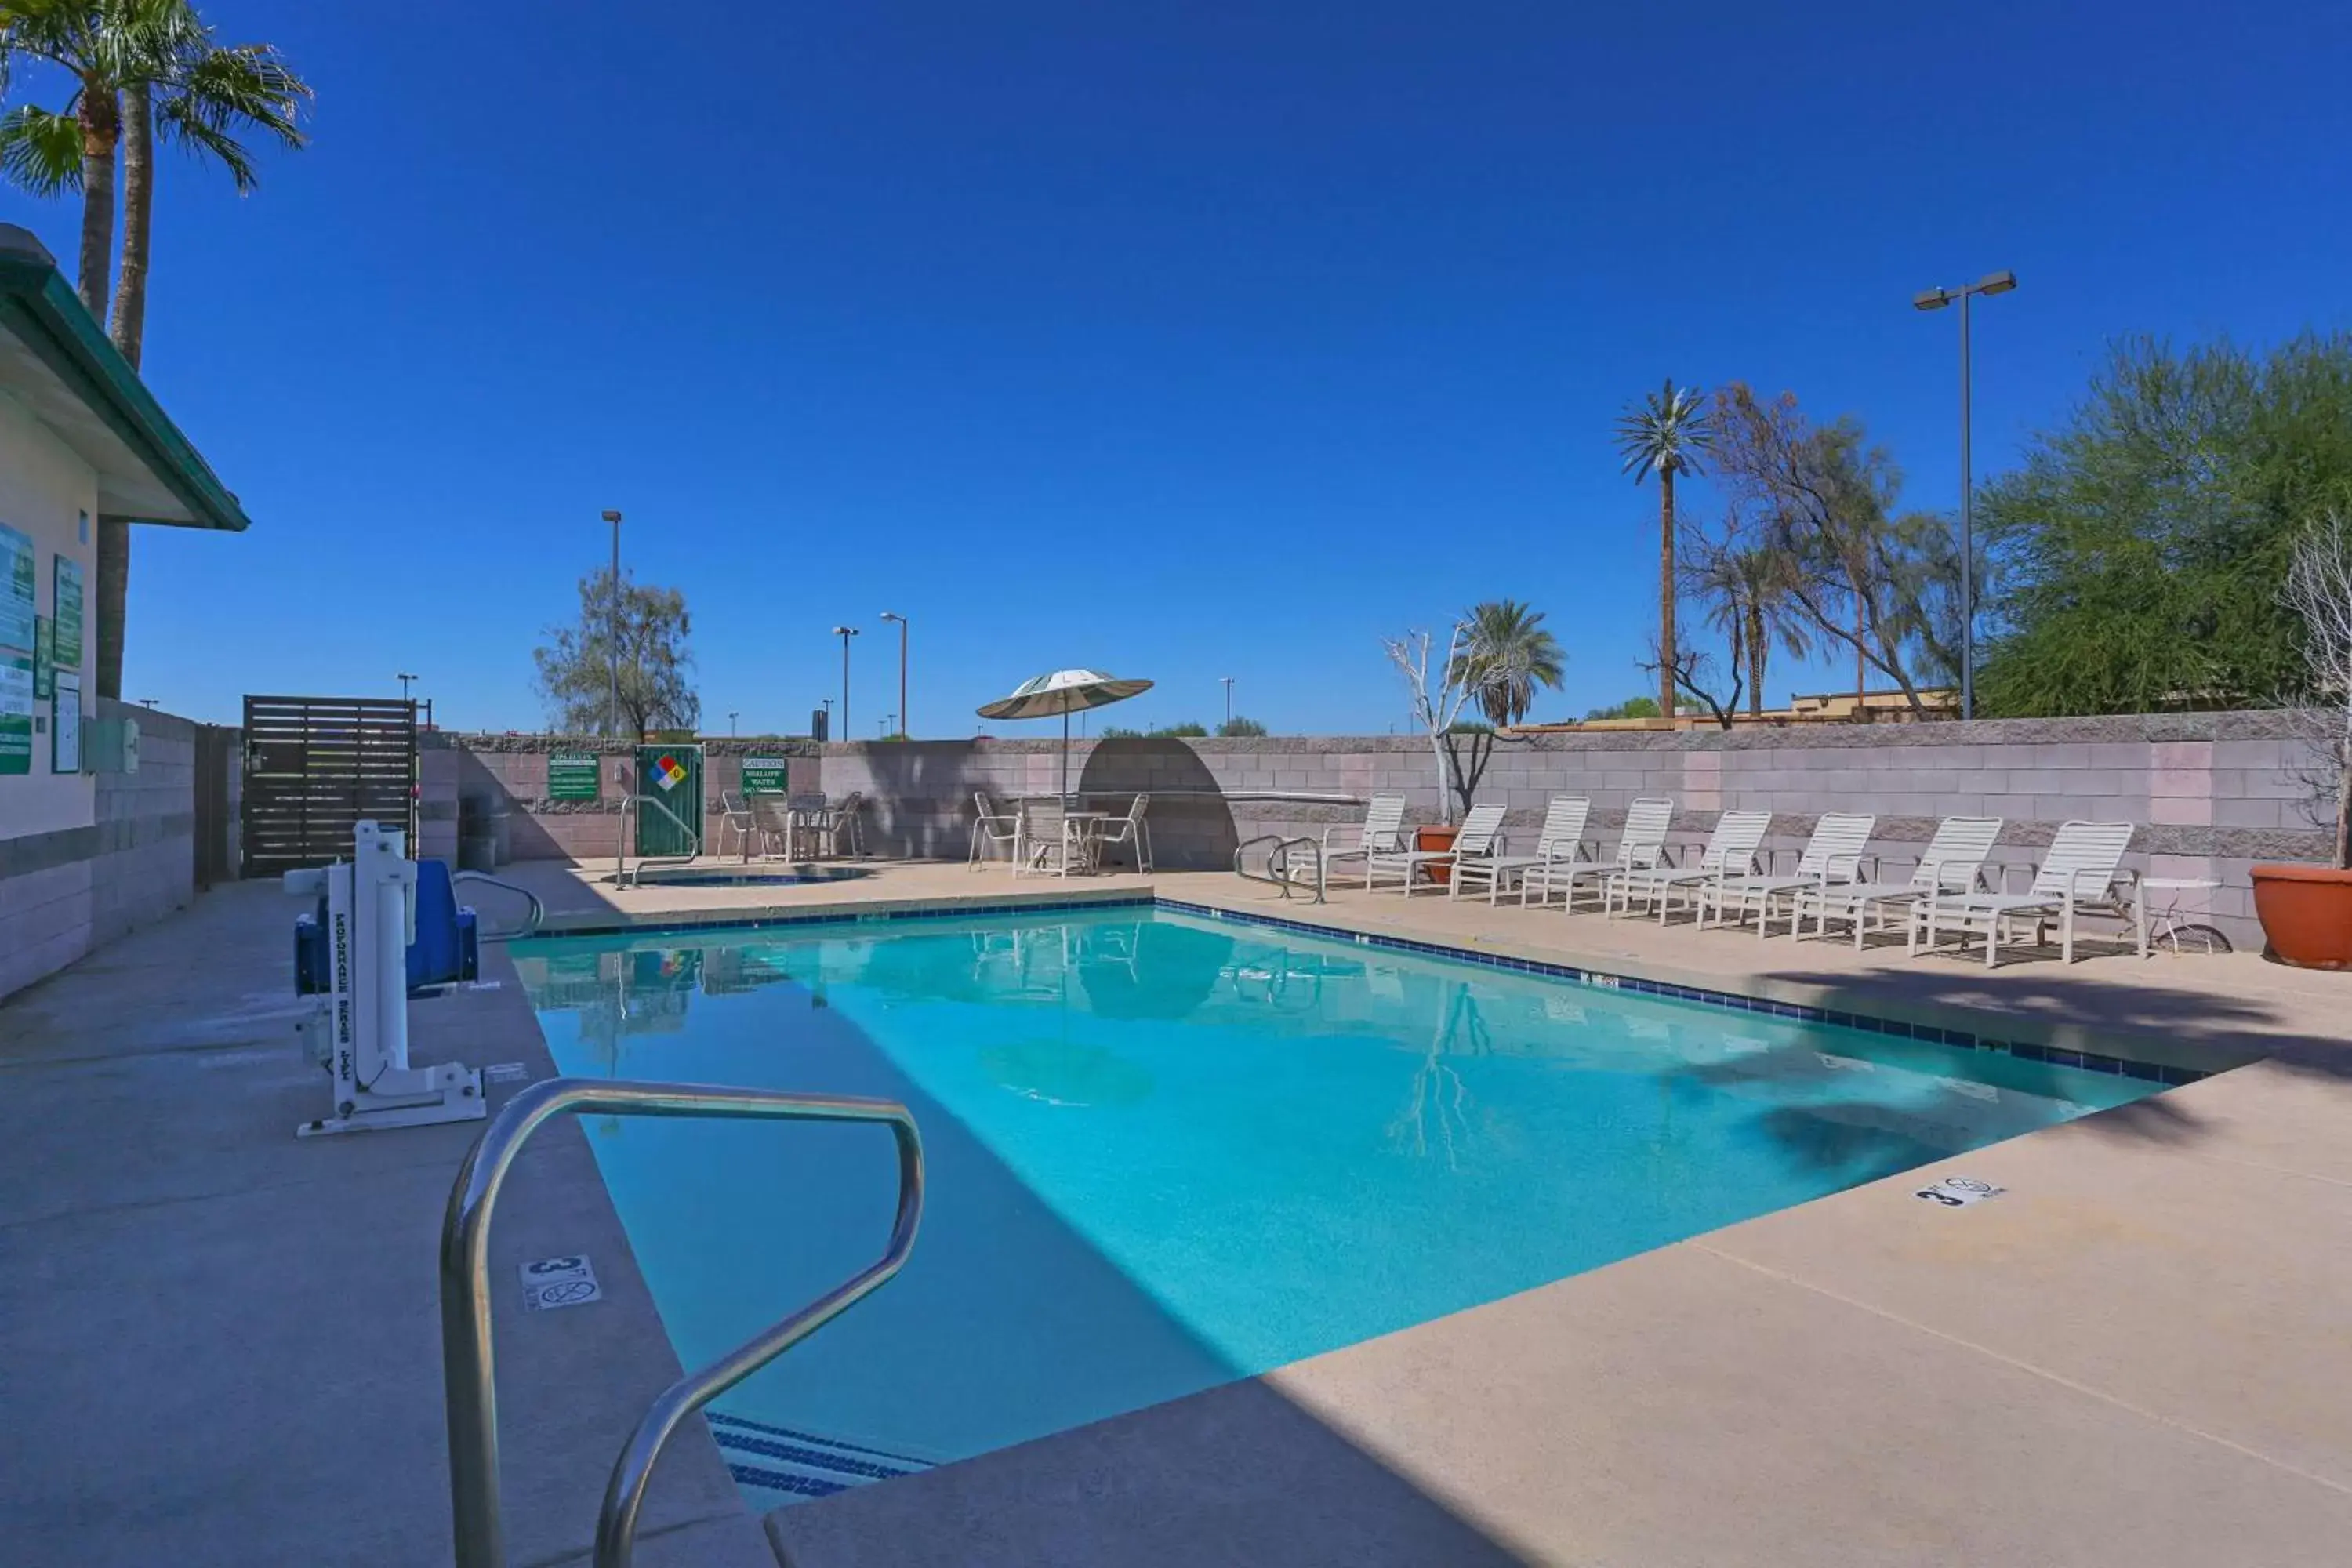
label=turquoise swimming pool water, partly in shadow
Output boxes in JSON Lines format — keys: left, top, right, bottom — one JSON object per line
{"left": 510, "top": 905, "right": 2157, "bottom": 1507}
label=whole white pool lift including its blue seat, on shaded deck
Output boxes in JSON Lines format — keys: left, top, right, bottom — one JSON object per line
{"left": 285, "top": 822, "right": 485, "bottom": 1138}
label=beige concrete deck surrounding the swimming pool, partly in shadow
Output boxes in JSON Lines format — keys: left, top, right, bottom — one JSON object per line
{"left": 0, "top": 862, "right": 2352, "bottom": 1568}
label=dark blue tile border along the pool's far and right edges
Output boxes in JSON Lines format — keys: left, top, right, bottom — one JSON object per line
{"left": 534, "top": 893, "right": 2209, "bottom": 1086}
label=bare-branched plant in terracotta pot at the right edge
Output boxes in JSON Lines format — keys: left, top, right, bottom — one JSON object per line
{"left": 2253, "top": 513, "right": 2352, "bottom": 968}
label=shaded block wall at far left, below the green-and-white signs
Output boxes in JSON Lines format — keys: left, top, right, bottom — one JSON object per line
{"left": 0, "top": 699, "right": 195, "bottom": 996}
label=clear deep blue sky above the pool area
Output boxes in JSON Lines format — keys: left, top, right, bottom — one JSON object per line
{"left": 0, "top": 0, "right": 2352, "bottom": 734}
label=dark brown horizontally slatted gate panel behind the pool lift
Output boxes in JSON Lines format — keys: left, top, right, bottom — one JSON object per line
{"left": 240, "top": 696, "right": 416, "bottom": 877}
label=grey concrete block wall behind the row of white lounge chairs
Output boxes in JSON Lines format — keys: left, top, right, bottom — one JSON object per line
{"left": 823, "top": 710, "right": 2331, "bottom": 940}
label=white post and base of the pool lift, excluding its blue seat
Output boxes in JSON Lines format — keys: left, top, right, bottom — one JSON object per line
{"left": 285, "top": 822, "right": 487, "bottom": 1138}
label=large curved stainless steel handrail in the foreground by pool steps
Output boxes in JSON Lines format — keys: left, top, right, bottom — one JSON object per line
{"left": 440, "top": 1079, "right": 922, "bottom": 1568}
